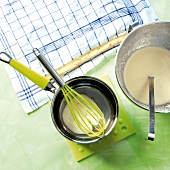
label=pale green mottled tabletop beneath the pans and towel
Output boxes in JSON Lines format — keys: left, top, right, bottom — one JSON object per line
{"left": 0, "top": 0, "right": 170, "bottom": 170}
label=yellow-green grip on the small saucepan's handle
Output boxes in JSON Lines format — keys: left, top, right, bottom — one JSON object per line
{"left": 9, "top": 59, "right": 50, "bottom": 89}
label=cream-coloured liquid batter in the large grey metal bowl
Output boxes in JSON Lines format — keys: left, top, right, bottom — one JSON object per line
{"left": 124, "top": 47, "right": 170, "bottom": 105}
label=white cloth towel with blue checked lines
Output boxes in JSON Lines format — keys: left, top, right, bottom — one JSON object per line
{"left": 0, "top": 0, "right": 157, "bottom": 113}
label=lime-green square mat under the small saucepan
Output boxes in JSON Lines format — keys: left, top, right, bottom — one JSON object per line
{"left": 67, "top": 76, "right": 135, "bottom": 161}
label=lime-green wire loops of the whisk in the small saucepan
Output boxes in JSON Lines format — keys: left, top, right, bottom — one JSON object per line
{"left": 61, "top": 84, "right": 106, "bottom": 137}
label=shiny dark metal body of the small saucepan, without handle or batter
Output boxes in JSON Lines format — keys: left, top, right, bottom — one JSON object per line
{"left": 51, "top": 76, "right": 118, "bottom": 144}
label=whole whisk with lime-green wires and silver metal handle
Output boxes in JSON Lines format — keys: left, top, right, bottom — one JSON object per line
{"left": 33, "top": 49, "right": 106, "bottom": 138}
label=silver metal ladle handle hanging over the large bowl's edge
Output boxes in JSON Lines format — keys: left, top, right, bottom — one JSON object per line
{"left": 148, "top": 77, "right": 155, "bottom": 141}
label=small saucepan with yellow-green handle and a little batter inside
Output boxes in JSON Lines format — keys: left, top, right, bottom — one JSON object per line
{"left": 0, "top": 52, "right": 118, "bottom": 144}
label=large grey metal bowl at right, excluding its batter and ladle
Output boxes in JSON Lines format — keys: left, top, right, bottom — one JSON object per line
{"left": 115, "top": 22, "right": 170, "bottom": 113}
